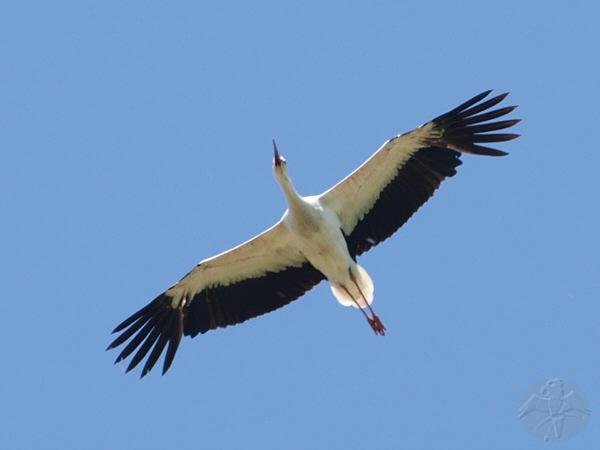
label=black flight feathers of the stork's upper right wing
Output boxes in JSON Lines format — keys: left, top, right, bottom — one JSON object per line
{"left": 346, "top": 91, "right": 520, "bottom": 256}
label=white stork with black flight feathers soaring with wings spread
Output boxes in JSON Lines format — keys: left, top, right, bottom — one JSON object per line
{"left": 107, "top": 91, "right": 519, "bottom": 377}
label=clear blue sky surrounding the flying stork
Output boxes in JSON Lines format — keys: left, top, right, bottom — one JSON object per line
{"left": 0, "top": 1, "right": 600, "bottom": 449}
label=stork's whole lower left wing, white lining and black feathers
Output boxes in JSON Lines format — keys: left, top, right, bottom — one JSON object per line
{"left": 107, "top": 221, "right": 324, "bottom": 377}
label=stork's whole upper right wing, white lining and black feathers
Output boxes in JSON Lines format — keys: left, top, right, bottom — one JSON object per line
{"left": 320, "top": 91, "right": 519, "bottom": 256}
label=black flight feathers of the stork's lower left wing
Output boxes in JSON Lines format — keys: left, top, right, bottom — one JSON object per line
{"left": 107, "top": 263, "right": 324, "bottom": 377}
